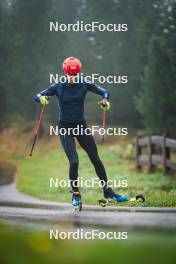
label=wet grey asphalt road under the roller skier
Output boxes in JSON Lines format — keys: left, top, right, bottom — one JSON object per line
{"left": 0, "top": 183, "right": 176, "bottom": 230}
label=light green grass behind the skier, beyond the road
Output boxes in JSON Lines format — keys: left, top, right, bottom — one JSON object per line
{"left": 13, "top": 144, "right": 176, "bottom": 207}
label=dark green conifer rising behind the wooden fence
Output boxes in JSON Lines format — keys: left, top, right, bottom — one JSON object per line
{"left": 136, "top": 37, "right": 176, "bottom": 134}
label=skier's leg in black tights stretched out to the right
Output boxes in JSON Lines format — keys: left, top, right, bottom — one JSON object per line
{"left": 77, "top": 134, "right": 107, "bottom": 185}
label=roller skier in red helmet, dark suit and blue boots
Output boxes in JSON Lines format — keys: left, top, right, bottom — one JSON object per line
{"left": 35, "top": 57, "right": 128, "bottom": 210}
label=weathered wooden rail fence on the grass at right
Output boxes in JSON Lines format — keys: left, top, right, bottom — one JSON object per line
{"left": 135, "top": 135, "right": 176, "bottom": 172}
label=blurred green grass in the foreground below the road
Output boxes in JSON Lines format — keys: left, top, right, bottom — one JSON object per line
{"left": 0, "top": 224, "right": 176, "bottom": 264}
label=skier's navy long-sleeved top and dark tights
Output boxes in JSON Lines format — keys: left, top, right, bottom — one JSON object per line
{"left": 35, "top": 81, "right": 109, "bottom": 192}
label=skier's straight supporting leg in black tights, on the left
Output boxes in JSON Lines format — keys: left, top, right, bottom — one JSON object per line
{"left": 60, "top": 135, "right": 79, "bottom": 192}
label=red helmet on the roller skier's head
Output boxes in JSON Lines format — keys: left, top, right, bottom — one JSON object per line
{"left": 63, "top": 57, "right": 82, "bottom": 75}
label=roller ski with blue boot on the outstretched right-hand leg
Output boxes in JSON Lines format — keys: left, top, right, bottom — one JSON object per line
{"left": 98, "top": 187, "right": 145, "bottom": 207}
